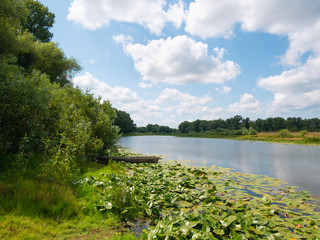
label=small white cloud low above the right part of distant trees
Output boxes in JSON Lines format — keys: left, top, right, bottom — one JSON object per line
{"left": 228, "top": 93, "right": 263, "bottom": 113}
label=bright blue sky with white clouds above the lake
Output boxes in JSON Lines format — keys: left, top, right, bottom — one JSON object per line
{"left": 40, "top": 0, "right": 320, "bottom": 128}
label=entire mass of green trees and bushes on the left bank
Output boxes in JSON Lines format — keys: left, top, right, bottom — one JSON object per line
{"left": 0, "top": 0, "right": 119, "bottom": 179}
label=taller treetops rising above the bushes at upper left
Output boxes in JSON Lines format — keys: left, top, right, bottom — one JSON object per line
{"left": 0, "top": 0, "right": 81, "bottom": 85}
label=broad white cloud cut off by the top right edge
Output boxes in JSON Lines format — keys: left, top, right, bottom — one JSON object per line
{"left": 185, "top": 0, "right": 320, "bottom": 38}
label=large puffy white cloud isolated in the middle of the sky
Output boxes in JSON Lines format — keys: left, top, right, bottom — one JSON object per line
{"left": 124, "top": 35, "right": 240, "bottom": 85}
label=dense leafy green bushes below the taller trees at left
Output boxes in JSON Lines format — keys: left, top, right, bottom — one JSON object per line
{"left": 0, "top": 61, "right": 119, "bottom": 178}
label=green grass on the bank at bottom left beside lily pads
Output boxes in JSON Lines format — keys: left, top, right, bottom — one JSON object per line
{"left": 0, "top": 160, "right": 136, "bottom": 239}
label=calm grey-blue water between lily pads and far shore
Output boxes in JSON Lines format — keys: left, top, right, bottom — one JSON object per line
{"left": 120, "top": 136, "right": 320, "bottom": 196}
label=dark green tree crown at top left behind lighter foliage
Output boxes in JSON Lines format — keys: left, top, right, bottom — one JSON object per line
{"left": 21, "top": 0, "right": 55, "bottom": 43}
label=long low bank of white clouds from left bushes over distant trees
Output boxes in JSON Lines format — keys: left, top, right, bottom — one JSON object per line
{"left": 72, "top": 72, "right": 223, "bottom": 127}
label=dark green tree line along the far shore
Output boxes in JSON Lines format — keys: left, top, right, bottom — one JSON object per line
{"left": 115, "top": 110, "right": 320, "bottom": 135}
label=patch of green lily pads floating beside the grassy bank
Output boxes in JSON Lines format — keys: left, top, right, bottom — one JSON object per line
{"left": 75, "top": 163, "right": 320, "bottom": 240}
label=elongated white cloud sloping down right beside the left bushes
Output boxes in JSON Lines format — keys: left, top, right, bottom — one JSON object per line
{"left": 72, "top": 72, "right": 140, "bottom": 104}
